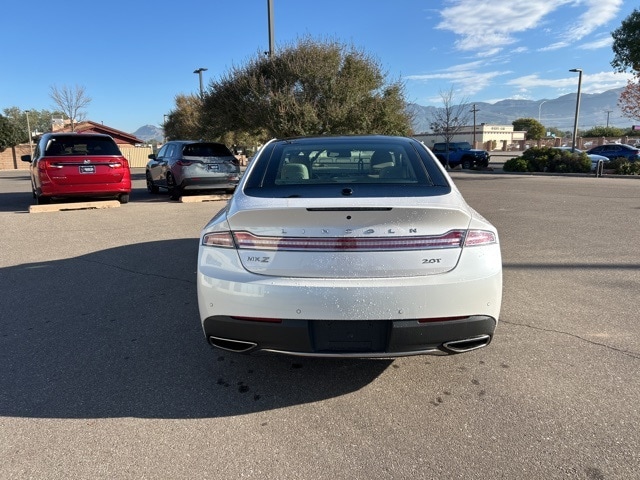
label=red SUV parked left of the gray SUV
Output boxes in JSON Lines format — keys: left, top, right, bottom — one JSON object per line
{"left": 21, "top": 133, "right": 131, "bottom": 204}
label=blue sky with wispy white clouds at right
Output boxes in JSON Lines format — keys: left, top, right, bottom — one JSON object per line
{"left": 0, "top": 0, "right": 637, "bottom": 132}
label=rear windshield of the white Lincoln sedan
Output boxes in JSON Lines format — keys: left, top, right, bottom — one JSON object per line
{"left": 246, "top": 140, "right": 448, "bottom": 196}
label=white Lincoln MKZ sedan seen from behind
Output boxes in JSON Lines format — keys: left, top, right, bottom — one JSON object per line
{"left": 197, "top": 136, "right": 502, "bottom": 357}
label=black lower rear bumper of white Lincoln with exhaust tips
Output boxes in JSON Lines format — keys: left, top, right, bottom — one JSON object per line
{"left": 203, "top": 315, "right": 497, "bottom": 358}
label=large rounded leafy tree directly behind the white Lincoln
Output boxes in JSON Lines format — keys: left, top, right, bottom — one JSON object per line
{"left": 202, "top": 37, "right": 411, "bottom": 139}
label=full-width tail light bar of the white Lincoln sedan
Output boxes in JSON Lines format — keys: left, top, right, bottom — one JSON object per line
{"left": 202, "top": 230, "right": 497, "bottom": 252}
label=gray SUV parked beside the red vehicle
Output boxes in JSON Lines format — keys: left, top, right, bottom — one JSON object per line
{"left": 146, "top": 140, "right": 240, "bottom": 200}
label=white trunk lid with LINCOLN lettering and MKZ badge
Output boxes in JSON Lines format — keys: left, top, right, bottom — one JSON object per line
{"left": 228, "top": 202, "right": 470, "bottom": 278}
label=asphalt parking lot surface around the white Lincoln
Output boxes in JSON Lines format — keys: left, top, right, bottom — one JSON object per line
{"left": 0, "top": 167, "right": 640, "bottom": 480}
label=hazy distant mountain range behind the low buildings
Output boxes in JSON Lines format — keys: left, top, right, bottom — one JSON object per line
{"left": 411, "top": 88, "right": 640, "bottom": 133}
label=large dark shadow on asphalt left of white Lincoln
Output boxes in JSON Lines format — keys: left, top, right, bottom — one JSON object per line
{"left": 0, "top": 239, "right": 392, "bottom": 418}
